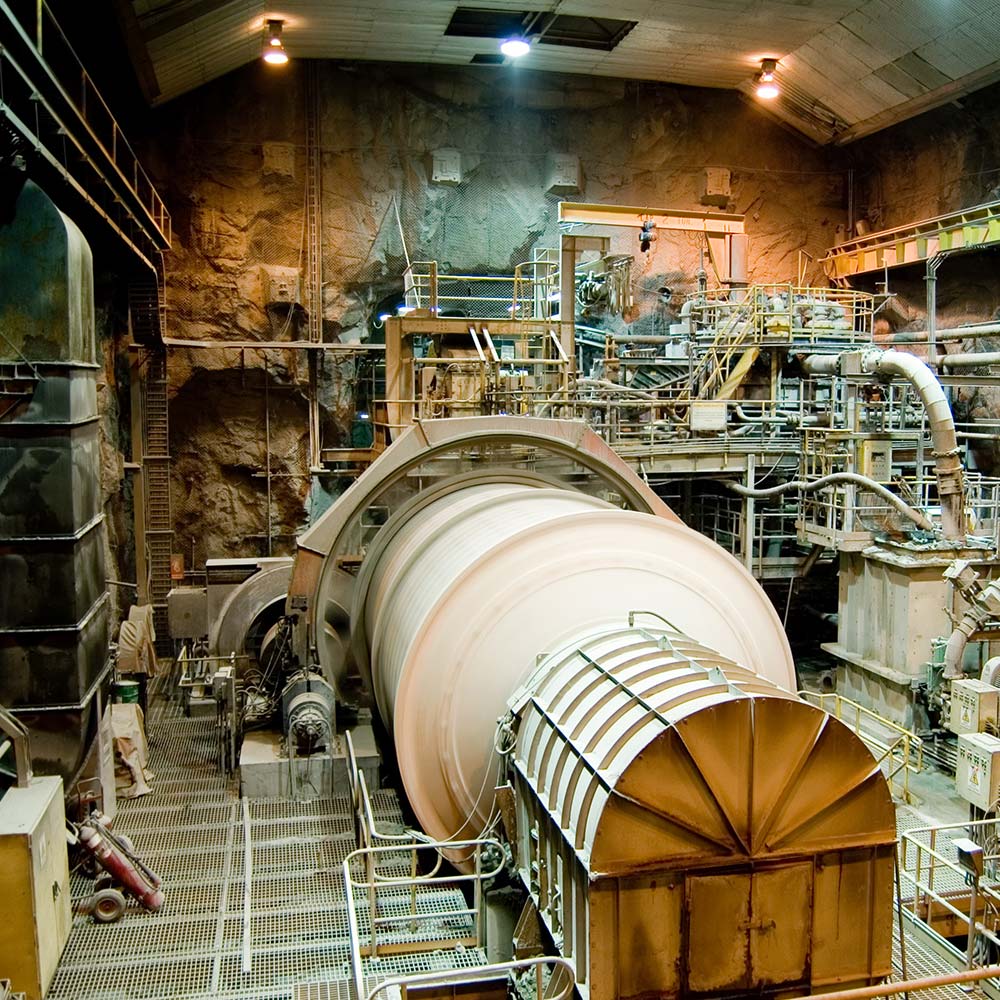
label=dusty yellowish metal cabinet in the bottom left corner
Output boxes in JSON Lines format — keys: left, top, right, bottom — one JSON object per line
{"left": 0, "top": 777, "right": 72, "bottom": 1000}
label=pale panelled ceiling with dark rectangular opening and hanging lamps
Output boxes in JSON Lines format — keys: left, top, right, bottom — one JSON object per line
{"left": 125, "top": 0, "right": 1000, "bottom": 143}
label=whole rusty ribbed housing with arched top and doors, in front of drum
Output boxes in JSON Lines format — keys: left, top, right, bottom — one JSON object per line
{"left": 511, "top": 624, "right": 895, "bottom": 997}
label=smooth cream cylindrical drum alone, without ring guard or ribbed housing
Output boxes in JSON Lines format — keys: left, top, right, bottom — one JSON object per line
{"left": 356, "top": 483, "right": 794, "bottom": 840}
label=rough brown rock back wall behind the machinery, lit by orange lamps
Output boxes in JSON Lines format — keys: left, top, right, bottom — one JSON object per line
{"left": 146, "top": 62, "right": 845, "bottom": 562}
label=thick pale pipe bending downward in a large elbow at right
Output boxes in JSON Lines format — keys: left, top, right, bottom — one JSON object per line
{"left": 804, "top": 350, "right": 965, "bottom": 539}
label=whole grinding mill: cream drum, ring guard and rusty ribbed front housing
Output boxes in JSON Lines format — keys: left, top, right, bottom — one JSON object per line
{"left": 289, "top": 418, "right": 895, "bottom": 1000}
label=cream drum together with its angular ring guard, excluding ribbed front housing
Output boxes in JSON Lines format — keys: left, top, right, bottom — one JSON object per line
{"left": 289, "top": 418, "right": 794, "bottom": 838}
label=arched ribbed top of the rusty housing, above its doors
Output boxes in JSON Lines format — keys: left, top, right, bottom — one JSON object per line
{"left": 514, "top": 627, "right": 895, "bottom": 874}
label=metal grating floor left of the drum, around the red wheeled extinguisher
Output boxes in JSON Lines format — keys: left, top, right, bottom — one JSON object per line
{"left": 48, "top": 703, "right": 485, "bottom": 1000}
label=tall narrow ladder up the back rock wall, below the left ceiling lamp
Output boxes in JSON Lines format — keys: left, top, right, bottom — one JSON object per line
{"left": 305, "top": 60, "right": 323, "bottom": 469}
